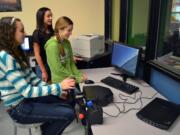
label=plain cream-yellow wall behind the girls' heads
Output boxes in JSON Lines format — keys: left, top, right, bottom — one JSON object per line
{"left": 0, "top": 0, "right": 104, "bottom": 36}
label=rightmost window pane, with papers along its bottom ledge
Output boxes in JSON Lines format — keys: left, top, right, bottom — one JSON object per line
{"left": 154, "top": 0, "right": 180, "bottom": 76}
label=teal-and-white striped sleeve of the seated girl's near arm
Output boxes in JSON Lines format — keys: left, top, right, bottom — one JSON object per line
{"left": 6, "top": 69, "right": 61, "bottom": 98}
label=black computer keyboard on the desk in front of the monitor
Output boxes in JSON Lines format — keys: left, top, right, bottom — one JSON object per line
{"left": 101, "top": 76, "right": 139, "bottom": 94}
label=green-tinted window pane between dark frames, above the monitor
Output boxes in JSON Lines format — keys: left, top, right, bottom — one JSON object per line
{"left": 127, "top": 0, "right": 150, "bottom": 49}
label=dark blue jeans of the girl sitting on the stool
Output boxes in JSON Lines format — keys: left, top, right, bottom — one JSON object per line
{"left": 8, "top": 96, "right": 75, "bottom": 135}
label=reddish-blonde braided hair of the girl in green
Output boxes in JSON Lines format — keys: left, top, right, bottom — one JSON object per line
{"left": 54, "top": 16, "right": 73, "bottom": 56}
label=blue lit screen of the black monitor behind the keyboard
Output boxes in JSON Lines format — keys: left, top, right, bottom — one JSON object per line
{"left": 111, "top": 43, "right": 139, "bottom": 76}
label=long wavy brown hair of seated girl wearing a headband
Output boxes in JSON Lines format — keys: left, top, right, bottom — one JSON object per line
{"left": 0, "top": 17, "right": 29, "bottom": 69}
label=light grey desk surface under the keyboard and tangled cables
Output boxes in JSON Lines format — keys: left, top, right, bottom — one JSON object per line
{"left": 80, "top": 67, "right": 180, "bottom": 135}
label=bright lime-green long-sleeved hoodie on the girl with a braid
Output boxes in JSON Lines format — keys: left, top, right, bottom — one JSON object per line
{"left": 45, "top": 37, "right": 83, "bottom": 83}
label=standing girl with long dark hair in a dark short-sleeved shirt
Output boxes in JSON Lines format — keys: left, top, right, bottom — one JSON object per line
{"left": 33, "top": 7, "right": 54, "bottom": 82}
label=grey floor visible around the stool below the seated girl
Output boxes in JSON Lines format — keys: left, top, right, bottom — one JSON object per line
{"left": 0, "top": 103, "right": 85, "bottom": 135}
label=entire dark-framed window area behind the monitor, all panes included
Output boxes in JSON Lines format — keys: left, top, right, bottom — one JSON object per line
{"left": 105, "top": 0, "right": 180, "bottom": 81}
